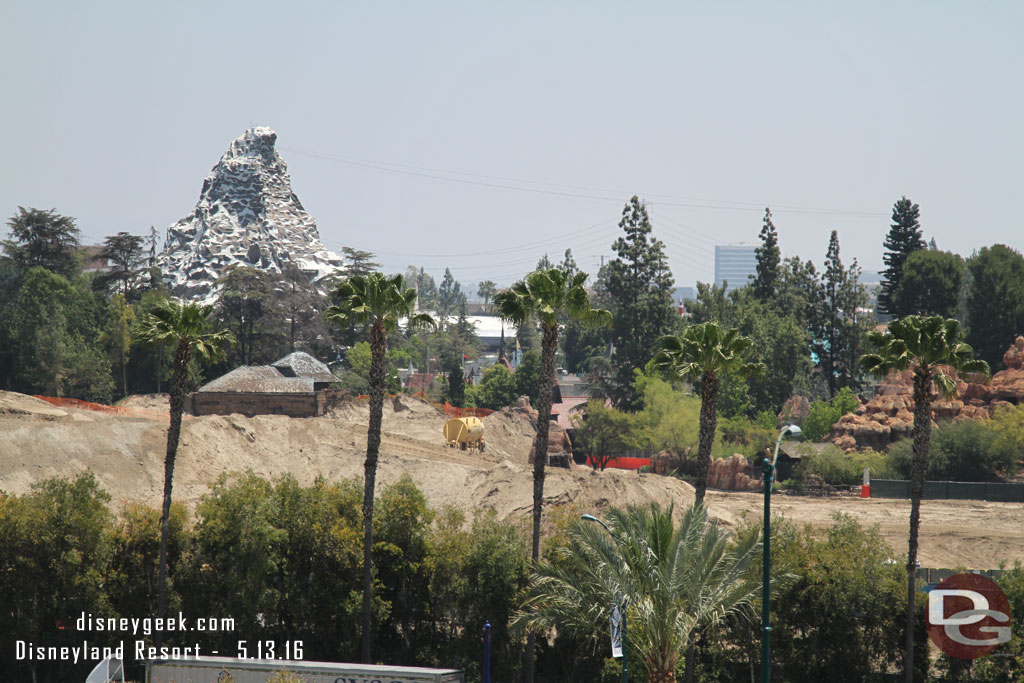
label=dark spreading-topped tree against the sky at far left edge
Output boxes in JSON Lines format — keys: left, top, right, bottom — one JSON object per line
{"left": 3, "top": 207, "right": 81, "bottom": 280}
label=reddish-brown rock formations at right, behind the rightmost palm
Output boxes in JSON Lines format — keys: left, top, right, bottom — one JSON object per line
{"left": 829, "top": 337, "right": 1024, "bottom": 451}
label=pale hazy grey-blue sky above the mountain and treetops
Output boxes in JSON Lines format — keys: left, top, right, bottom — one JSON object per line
{"left": 0, "top": 0, "right": 1024, "bottom": 286}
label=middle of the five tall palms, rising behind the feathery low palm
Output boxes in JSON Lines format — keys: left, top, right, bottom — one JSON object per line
{"left": 495, "top": 268, "right": 611, "bottom": 681}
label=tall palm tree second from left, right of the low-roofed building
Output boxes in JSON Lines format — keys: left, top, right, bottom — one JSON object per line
{"left": 324, "top": 271, "right": 434, "bottom": 664}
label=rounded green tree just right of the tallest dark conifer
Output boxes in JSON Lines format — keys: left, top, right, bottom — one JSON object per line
{"left": 896, "top": 249, "right": 965, "bottom": 317}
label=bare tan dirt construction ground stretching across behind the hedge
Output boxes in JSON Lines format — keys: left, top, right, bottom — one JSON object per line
{"left": 0, "top": 391, "right": 1024, "bottom": 569}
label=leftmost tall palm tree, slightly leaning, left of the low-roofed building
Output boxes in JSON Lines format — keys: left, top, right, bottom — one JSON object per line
{"left": 136, "top": 301, "right": 234, "bottom": 617}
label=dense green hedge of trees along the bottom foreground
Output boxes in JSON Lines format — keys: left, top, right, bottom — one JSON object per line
{"left": 0, "top": 473, "right": 1024, "bottom": 683}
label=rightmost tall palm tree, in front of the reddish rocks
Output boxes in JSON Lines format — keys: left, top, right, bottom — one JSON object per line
{"left": 860, "top": 315, "right": 989, "bottom": 683}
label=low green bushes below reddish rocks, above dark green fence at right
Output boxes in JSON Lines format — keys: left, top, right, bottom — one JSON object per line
{"left": 888, "top": 420, "right": 1017, "bottom": 481}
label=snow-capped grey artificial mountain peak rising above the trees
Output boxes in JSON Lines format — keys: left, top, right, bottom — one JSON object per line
{"left": 160, "top": 127, "right": 343, "bottom": 303}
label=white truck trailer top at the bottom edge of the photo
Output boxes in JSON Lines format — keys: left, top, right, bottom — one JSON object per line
{"left": 145, "top": 656, "right": 465, "bottom": 683}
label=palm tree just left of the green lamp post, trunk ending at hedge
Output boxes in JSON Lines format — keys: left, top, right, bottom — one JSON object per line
{"left": 654, "top": 323, "right": 764, "bottom": 503}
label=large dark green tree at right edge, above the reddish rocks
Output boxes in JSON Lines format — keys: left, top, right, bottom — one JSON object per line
{"left": 967, "top": 245, "right": 1024, "bottom": 368}
